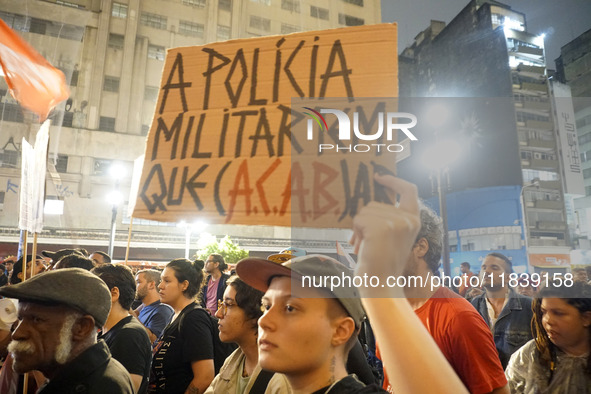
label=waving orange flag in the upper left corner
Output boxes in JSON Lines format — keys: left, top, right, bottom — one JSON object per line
{"left": 0, "top": 19, "right": 70, "bottom": 121}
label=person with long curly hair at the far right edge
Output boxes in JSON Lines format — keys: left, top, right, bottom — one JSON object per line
{"left": 505, "top": 280, "right": 591, "bottom": 394}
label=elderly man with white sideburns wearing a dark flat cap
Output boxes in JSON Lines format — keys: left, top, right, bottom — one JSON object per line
{"left": 0, "top": 268, "right": 134, "bottom": 394}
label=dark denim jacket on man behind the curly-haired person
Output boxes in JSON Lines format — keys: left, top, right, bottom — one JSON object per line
{"left": 472, "top": 290, "right": 533, "bottom": 369}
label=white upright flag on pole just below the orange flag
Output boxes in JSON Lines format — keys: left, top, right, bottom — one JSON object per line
{"left": 19, "top": 120, "right": 50, "bottom": 233}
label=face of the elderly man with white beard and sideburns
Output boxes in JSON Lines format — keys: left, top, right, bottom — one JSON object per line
{"left": 8, "top": 301, "right": 75, "bottom": 377}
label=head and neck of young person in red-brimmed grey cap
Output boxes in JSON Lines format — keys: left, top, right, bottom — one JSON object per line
{"left": 236, "top": 255, "right": 383, "bottom": 393}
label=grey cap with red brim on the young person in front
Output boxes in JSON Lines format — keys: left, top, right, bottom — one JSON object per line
{"left": 236, "top": 254, "right": 365, "bottom": 327}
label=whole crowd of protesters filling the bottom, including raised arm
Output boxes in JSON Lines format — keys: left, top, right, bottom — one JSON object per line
{"left": 0, "top": 175, "right": 591, "bottom": 394}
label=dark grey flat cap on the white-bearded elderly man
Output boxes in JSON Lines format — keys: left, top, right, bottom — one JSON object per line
{"left": 0, "top": 268, "right": 111, "bottom": 326}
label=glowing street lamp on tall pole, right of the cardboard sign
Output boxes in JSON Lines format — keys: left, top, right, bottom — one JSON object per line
{"left": 423, "top": 140, "right": 461, "bottom": 276}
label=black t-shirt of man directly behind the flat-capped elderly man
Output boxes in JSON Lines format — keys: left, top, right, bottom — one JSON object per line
{"left": 100, "top": 316, "right": 152, "bottom": 394}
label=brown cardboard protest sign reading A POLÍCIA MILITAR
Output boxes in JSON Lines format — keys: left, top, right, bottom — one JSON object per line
{"left": 133, "top": 24, "right": 398, "bottom": 227}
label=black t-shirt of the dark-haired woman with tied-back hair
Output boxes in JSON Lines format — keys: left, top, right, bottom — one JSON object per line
{"left": 150, "top": 303, "right": 213, "bottom": 393}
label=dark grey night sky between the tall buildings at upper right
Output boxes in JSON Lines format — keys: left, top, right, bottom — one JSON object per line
{"left": 381, "top": 0, "right": 591, "bottom": 69}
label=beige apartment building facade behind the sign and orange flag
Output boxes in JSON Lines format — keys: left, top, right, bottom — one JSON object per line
{"left": 0, "top": 0, "right": 381, "bottom": 260}
